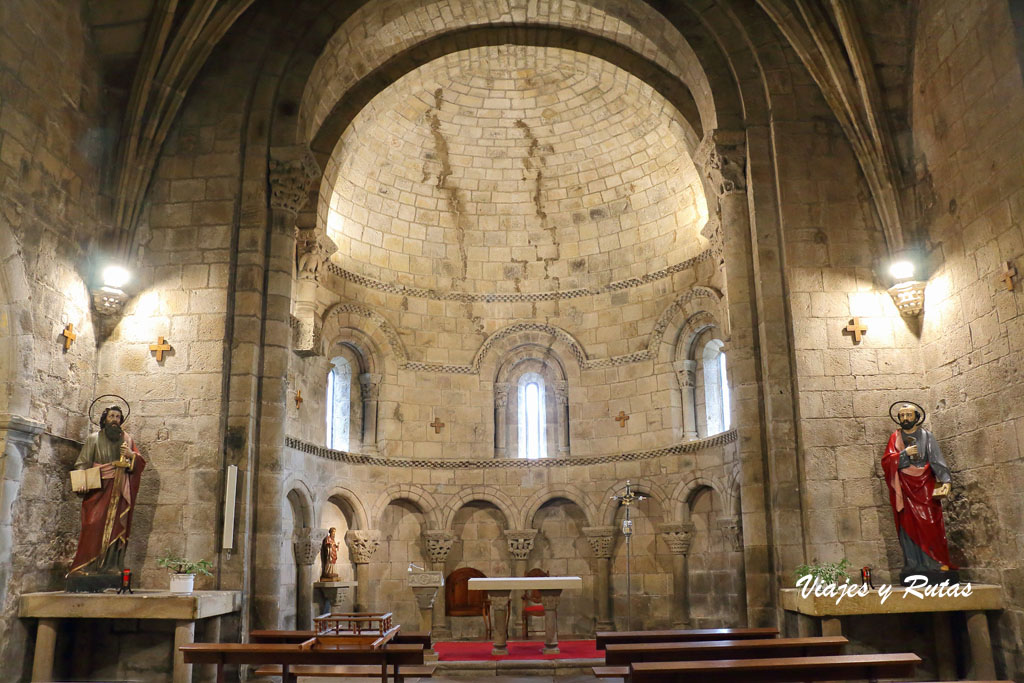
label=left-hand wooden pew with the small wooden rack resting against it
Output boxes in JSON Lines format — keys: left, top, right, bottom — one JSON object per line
{"left": 180, "top": 641, "right": 423, "bottom": 683}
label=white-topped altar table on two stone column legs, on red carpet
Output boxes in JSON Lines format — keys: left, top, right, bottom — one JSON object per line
{"left": 468, "top": 577, "right": 583, "bottom": 654}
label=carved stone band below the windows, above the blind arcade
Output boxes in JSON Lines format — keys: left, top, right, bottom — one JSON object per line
{"left": 285, "top": 429, "right": 738, "bottom": 470}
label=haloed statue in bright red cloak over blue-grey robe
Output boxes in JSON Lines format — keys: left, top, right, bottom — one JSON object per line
{"left": 882, "top": 401, "right": 957, "bottom": 584}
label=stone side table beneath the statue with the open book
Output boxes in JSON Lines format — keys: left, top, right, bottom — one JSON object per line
{"left": 18, "top": 590, "right": 242, "bottom": 683}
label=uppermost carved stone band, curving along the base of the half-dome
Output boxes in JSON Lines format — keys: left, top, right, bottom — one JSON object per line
{"left": 327, "top": 249, "right": 714, "bottom": 303}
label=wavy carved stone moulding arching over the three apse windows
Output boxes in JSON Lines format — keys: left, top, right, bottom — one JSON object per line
{"left": 324, "top": 286, "right": 722, "bottom": 375}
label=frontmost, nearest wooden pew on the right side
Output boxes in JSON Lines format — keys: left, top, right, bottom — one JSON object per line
{"left": 630, "top": 652, "right": 921, "bottom": 683}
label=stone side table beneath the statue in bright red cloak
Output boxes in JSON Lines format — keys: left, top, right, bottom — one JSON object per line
{"left": 779, "top": 584, "right": 1002, "bottom": 681}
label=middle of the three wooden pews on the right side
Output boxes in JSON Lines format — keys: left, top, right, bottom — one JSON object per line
{"left": 594, "top": 636, "right": 849, "bottom": 678}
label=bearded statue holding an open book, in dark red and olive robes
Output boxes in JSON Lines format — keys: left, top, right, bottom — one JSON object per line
{"left": 67, "top": 396, "right": 145, "bottom": 592}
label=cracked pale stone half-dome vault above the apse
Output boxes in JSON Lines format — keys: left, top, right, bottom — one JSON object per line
{"left": 322, "top": 45, "right": 708, "bottom": 293}
